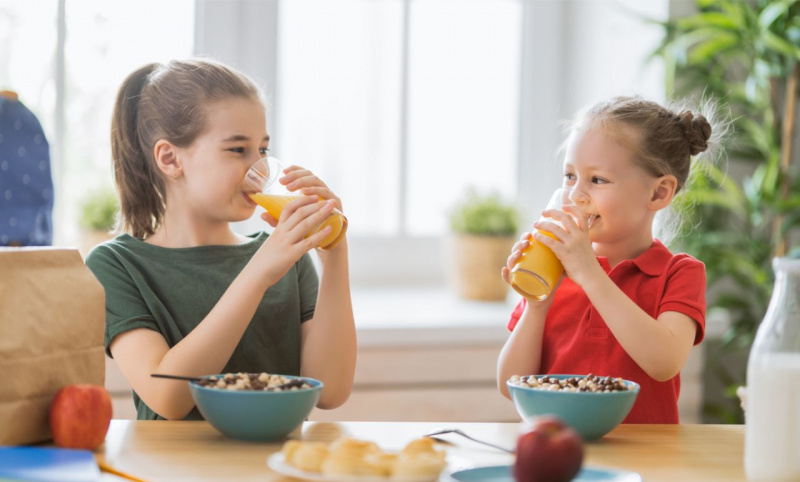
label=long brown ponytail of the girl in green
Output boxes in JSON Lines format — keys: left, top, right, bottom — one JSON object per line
{"left": 111, "top": 63, "right": 165, "bottom": 238}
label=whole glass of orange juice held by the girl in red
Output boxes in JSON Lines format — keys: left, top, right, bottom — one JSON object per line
{"left": 511, "top": 188, "right": 594, "bottom": 301}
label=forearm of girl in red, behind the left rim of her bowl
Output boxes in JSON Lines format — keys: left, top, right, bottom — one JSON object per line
{"left": 497, "top": 302, "right": 547, "bottom": 398}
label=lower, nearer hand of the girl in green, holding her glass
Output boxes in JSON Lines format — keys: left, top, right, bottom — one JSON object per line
{"left": 259, "top": 195, "right": 336, "bottom": 286}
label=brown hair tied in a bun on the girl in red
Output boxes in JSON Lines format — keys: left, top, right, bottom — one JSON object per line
{"left": 573, "top": 97, "right": 717, "bottom": 190}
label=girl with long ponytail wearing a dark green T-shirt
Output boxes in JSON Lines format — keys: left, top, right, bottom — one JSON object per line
{"left": 86, "top": 60, "right": 356, "bottom": 419}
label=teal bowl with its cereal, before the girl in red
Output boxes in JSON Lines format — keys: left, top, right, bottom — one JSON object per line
{"left": 506, "top": 374, "right": 639, "bottom": 440}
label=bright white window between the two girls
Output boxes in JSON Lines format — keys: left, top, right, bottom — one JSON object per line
{"left": 273, "top": 0, "right": 522, "bottom": 236}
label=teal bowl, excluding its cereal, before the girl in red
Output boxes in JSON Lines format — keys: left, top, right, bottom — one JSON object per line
{"left": 506, "top": 375, "right": 639, "bottom": 440}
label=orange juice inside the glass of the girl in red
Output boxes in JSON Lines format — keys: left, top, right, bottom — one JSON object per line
{"left": 511, "top": 231, "right": 564, "bottom": 301}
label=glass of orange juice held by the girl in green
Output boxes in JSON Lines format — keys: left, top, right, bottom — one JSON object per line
{"left": 242, "top": 157, "right": 347, "bottom": 249}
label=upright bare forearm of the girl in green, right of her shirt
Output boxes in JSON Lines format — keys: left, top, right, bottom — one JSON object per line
{"left": 301, "top": 243, "right": 356, "bottom": 409}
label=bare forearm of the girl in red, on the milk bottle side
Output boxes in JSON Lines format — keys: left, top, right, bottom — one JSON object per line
{"left": 583, "top": 274, "right": 691, "bottom": 381}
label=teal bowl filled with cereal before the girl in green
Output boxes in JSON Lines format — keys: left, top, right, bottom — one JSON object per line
{"left": 189, "top": 373, "right": 322, "bottom": 442}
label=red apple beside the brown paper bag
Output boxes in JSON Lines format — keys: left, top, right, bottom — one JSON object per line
{"left": 50, "top": 384, "right": 111, "bottom": 450}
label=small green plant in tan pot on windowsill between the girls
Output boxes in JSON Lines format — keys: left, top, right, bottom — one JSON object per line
{"left": 446, "top": 188, "right": 519, "bottom": 301}
